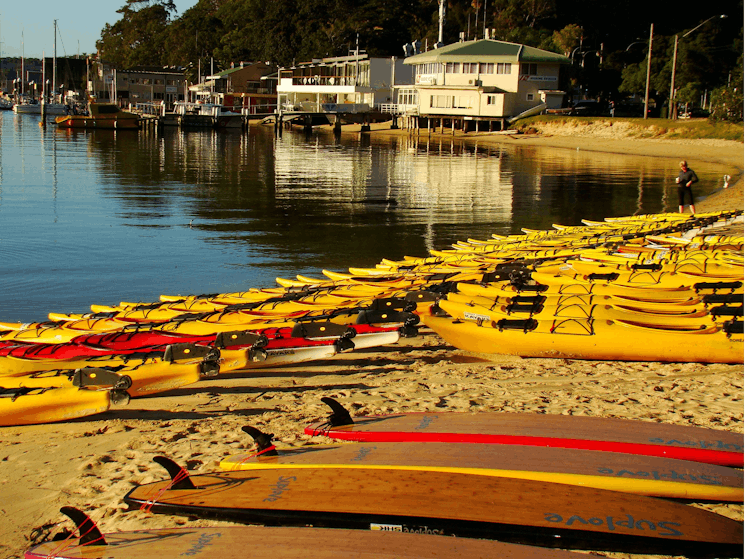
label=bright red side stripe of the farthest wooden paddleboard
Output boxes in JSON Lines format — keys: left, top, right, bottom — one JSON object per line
{"left": 305, "top": 427, "right": 743, "bottom": 468}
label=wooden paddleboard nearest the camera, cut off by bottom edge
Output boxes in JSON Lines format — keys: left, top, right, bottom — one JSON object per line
{"left": 24, "top": 507, "right": 586, "bottom": 559}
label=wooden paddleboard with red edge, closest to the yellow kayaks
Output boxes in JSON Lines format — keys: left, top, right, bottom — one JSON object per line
{"left": 305, "top": 398, "right": 744, "bottom": 468}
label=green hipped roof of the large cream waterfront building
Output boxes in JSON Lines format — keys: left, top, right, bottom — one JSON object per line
{"left": 404, "top": 39, "right": 571, "bottom": 64}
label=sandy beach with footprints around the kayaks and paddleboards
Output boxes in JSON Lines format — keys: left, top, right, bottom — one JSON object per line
{"left": 0, "top": 125, "right": 745, "bottom": 559}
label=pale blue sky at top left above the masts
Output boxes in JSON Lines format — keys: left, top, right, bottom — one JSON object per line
{"left": 0, "top": 0, "right": 198, "bottom": 58}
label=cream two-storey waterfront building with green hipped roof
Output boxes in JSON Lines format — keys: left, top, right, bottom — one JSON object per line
{"left": 399, "top": 39, "right": 570, "bottom": 127}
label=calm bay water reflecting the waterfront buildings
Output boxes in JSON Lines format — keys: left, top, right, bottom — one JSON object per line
{"left": 0, "top": 112, "right": 721, "bottom": 321}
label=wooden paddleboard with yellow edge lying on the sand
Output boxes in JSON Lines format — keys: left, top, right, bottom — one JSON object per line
{"left": 220, "top": 443, "right": 745, "bottom": 502}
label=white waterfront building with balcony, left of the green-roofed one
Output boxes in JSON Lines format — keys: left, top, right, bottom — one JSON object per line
{"left": 277, "top": 52, "right": 413, "bottom": 113}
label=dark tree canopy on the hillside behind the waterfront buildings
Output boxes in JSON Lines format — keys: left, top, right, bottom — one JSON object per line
{"left": 97, "top": 0, "right": 743, "bottom": 111}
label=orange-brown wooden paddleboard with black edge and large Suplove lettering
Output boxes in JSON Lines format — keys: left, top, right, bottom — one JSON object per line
{"left": 124, "top": 457, "right": 743, "bottom": 555}
